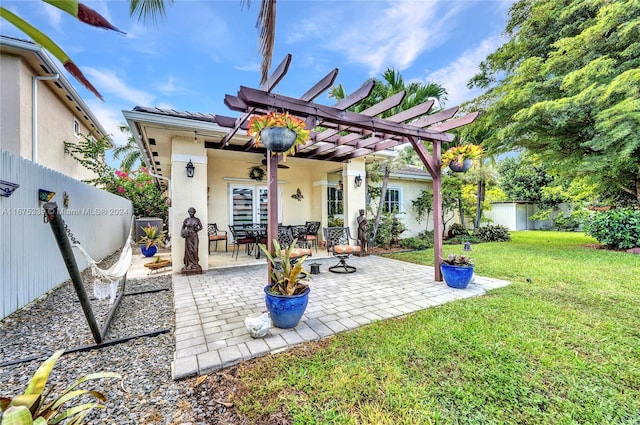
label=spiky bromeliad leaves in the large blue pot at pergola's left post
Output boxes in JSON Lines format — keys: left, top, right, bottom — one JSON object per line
{"left": 260, "top": 239, "right": 309, "bottom": 295}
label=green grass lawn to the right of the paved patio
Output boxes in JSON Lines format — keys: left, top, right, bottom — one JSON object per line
{"left": 235, "top": 232, "right": 640, "bottom": 425}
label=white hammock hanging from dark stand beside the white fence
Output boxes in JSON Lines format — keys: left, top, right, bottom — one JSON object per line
{"left": 71, "top": 227, "right": 133, "bottom": 303}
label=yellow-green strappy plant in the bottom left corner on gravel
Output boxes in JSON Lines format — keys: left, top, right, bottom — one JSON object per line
{"left": 0, "top": 350, "right": 121, "bottom": 425}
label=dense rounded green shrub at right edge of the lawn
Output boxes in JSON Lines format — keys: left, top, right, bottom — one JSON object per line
{"left": 584, "top": 208, "right": 640, "bottom": 249}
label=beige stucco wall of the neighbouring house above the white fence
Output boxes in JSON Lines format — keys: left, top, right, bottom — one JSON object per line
{"left": 0, "top": 54, "right": 96, "bottom": 180}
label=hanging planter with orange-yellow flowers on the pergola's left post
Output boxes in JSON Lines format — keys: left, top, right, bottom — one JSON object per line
{"left": 247, "top": 112, "right": 311, "bottom": 158}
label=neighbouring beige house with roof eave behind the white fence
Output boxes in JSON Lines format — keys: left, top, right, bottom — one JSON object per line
{"left": 0, "top": 36, "right": 107, "bottom": 180}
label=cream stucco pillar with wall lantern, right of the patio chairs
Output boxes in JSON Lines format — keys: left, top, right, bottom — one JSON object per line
{"left": 342, "top": 158, "right": 367, "bottom": 245}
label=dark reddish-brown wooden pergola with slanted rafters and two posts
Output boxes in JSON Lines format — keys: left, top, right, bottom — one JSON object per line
{"left": 210, "top": 54, "right": 478, "bottom": 281}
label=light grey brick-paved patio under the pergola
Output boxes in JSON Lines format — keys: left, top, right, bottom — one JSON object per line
{"left": 172, "top": 256, "right": 509, "bottom": 379}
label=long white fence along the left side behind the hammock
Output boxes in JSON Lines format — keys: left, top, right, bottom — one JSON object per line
{"left": 0, "top": 149, "right": 133, "bottom": 319}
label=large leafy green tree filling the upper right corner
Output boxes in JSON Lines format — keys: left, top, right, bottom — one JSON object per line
{"left": 469, "top": 0, "right": 640, "bottom": 203}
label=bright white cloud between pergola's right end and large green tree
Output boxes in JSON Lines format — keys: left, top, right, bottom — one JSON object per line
{"left": 425, "top": 36, "right": 504, "bottom": 106}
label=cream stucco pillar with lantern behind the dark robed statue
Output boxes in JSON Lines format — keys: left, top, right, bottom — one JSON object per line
{"left": 170, "top": 138, "right": 209, "bottom": 272}
